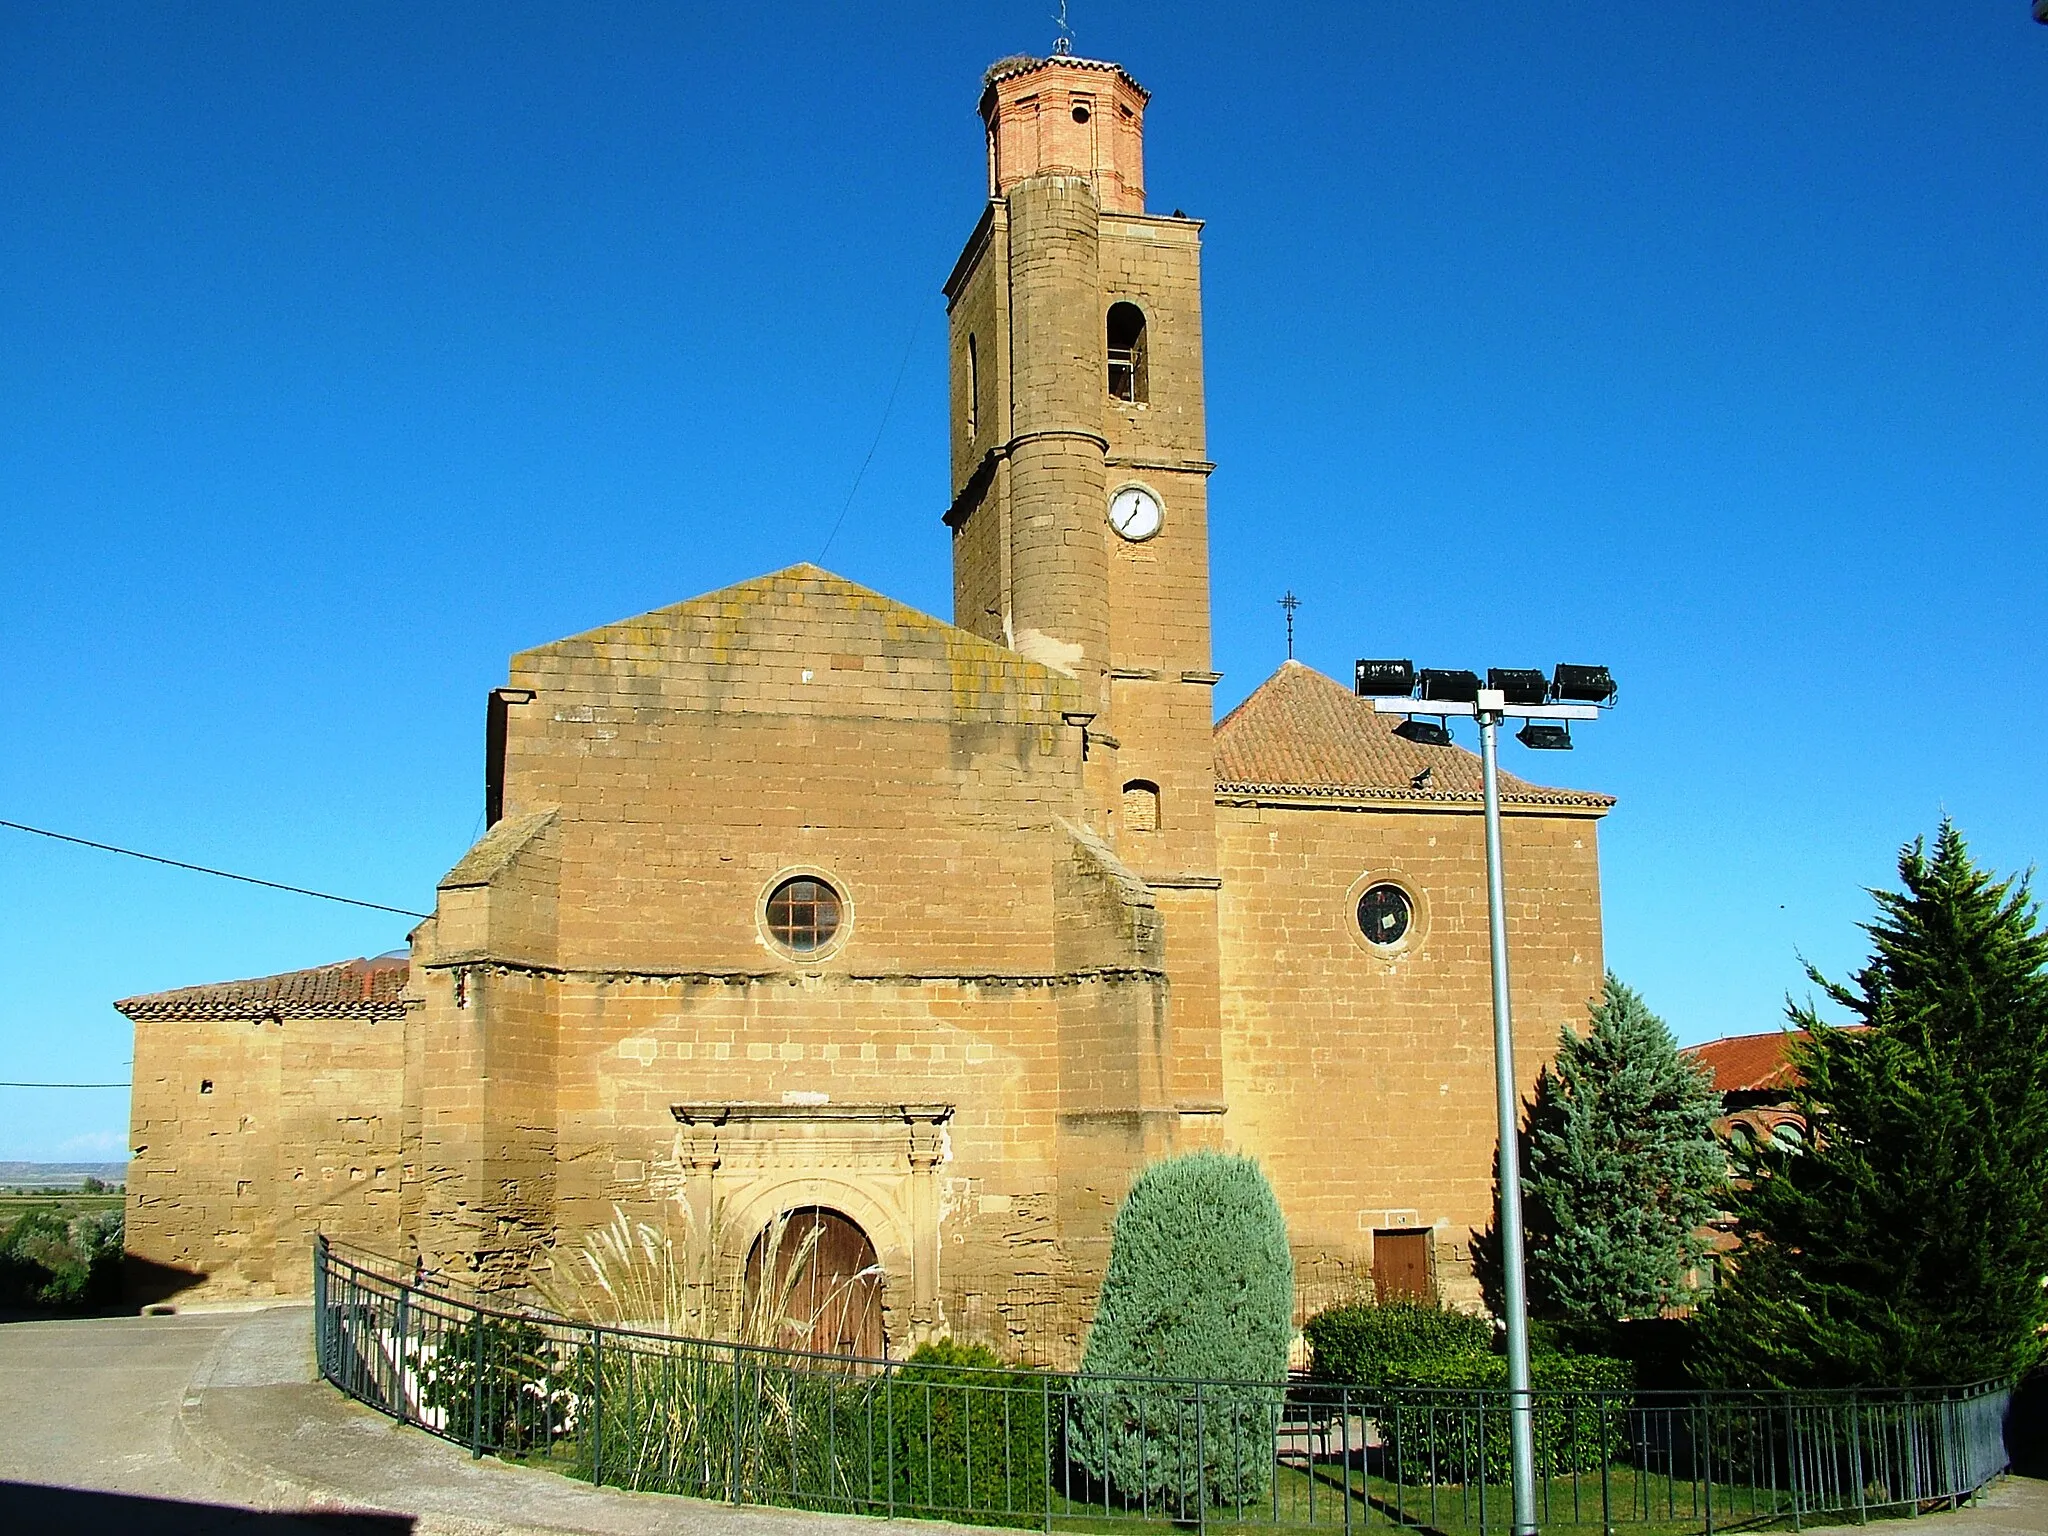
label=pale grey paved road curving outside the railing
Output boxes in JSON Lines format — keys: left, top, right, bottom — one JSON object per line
{"left": 0, "top": 1307, "right": 2048, "bottom": 1536}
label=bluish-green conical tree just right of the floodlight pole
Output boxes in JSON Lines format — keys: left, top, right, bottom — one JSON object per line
{"left": 1473, "top": 975, "right": 1729, "bottom": 1335}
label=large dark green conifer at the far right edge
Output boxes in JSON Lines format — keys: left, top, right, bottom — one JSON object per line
{"left": 1702, "top": 821, "right": 2048, "bottom": 1386}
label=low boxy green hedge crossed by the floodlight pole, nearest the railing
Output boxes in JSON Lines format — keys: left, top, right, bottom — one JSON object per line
{"left": 1376, "top": 1354, "right": 1630, "bottom": 1483}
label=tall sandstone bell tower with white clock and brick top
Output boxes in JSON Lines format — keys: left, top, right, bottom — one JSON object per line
{"left": 946, "top": 55, "right": 1221, "bottom": 1124}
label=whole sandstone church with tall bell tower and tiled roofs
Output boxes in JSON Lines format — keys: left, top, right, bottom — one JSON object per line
{"left": 117, "top": 55, "right": 1612, "bottom": 1360}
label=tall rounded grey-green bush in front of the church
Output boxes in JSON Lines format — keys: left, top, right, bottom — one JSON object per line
{"left": 1067, "top": 1151, "right": 1294, "bottom": 1516}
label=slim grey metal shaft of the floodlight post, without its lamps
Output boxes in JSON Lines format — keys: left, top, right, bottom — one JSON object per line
{"left": 1477, "top": 688, "right": 1536, "bottom": 1536}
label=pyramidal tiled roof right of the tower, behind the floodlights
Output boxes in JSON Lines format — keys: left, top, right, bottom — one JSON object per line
{"left": 1217, "top": 662, "right": 1614, "bottom": 815}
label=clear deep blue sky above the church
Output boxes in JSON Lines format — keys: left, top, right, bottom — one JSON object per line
{"left": 0, "top": 0, "right": 2048, "bottom": 1157}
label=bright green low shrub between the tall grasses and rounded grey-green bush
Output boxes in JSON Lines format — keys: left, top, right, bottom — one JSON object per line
{"left": 872, "top": 1339, "right": 1049, "bottom": 1526}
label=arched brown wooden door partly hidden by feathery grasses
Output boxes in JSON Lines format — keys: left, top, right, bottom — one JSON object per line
{"left": 748, "top": 1206, "right": 885, "bottom": 1360}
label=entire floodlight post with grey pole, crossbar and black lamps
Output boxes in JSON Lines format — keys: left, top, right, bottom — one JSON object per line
{"left": 1358, "top": 662, "right": 1614, "bottom": 1536}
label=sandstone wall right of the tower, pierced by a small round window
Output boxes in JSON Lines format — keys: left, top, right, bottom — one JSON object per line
{"left": 1217, "top": 805, "right": 1602, "bottom": 1300}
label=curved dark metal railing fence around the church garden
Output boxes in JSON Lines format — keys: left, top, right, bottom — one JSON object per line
{"left": 313, "top": 1241, "right": 2009, "bottom": 1536}
